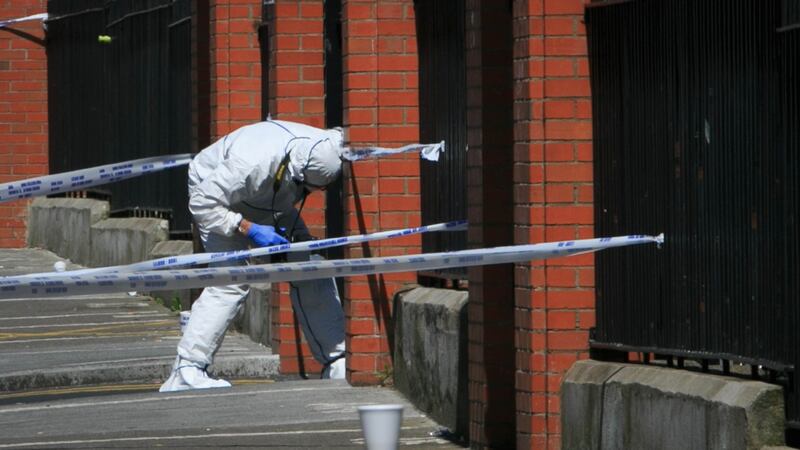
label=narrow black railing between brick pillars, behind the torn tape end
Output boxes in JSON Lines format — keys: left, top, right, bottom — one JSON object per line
{"left": 414, "top": 0, "right": 467, "bottom": 279}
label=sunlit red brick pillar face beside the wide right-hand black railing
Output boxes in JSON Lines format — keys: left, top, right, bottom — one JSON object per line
{"left": 514, "top": 0, "right": 594, "bottom": 449}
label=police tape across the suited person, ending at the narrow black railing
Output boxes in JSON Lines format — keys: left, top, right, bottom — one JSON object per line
{"left": 9, "top": 220, "right": 467, "bottom": 280}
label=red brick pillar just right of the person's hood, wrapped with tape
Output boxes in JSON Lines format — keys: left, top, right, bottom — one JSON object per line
{"left": 343, "top": 0, "right": 420, "bottom": 384}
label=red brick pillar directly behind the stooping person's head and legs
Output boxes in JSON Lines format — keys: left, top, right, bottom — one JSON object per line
{"left": 265, "top": 0, "right": 325, "bottom": 378}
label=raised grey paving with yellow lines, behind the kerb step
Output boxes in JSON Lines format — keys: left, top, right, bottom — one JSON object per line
{"left": 0, "top": 249, "right": 279, "bottom": 392}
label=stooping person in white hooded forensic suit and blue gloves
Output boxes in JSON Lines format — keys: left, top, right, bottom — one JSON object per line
{"left": 160, "top": 120, "right": 345, "bottom": 392}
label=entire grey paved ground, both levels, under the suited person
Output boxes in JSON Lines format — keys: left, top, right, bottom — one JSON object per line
{"left": 0, "top": 249, "right": 460, "bottom": 450}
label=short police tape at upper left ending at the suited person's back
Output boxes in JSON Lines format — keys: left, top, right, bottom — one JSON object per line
{"left": 0, "top": 153, "right": 192, "bottom": 202}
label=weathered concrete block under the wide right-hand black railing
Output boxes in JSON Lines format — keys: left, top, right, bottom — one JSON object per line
{"left": 561, "top": 360, "right": 784, "bottom": 449}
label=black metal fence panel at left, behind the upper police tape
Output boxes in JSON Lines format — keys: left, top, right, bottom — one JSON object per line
{"left": 47, "top": 0, "right": 196, "bottom": 230}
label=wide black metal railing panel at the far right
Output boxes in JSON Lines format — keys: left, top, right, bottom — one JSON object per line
{"left": 586, "top": 0, "right": 800, "bottom": 426}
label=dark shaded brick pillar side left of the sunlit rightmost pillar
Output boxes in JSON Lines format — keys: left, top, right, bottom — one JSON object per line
{"left": 466, "top": 0, "right": 515, "bottom": 448}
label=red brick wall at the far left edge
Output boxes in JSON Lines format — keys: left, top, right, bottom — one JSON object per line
{"left": 0, "top": 0, "right": 48, "bottom": 248}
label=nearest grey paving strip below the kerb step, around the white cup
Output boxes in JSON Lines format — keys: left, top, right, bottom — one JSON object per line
{"left": 0, "top": 380, "right": 460, "bottom": 449}
